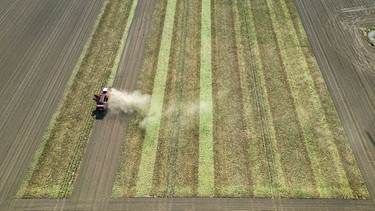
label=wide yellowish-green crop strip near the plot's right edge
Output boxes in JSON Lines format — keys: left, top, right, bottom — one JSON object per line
{"left": 268, "top": 1, "right": 351, "bottom": 198}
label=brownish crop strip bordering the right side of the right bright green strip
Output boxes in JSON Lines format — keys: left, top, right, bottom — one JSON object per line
{"left": 212, "top": 0, "right": 253, "bottom": 197}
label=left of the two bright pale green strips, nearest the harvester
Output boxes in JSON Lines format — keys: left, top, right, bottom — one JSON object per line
{"left": 136, "top": 0, "right": 176, "bottom": 196}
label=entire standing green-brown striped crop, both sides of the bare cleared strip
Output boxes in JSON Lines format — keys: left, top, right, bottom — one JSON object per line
{"left": 18, "top": 0, "right": 369, "bottom": 199}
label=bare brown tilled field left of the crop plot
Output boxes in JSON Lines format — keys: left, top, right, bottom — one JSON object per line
{"left": 0, "top": 0, "right": 103, "bottom": 210}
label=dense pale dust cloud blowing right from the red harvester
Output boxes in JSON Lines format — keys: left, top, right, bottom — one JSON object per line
{"left": 108, "top": 88, "right": 151, "bottom": 116}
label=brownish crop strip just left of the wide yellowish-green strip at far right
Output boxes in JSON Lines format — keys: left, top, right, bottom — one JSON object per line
{"left": 250, "top": 0, "right": 318, "bottom": 198}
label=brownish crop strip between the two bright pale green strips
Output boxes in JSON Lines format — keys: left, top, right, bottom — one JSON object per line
{"left": 152, "top": 0, "right": 200, "bottom": 197}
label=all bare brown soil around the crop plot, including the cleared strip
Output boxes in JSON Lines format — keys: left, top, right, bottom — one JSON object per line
{"left": 0, "top": 0, "right": 375, "bottom": 210}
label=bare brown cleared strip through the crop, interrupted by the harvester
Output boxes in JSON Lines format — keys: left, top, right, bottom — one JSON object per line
{"left": 73, "top": 0, "right": 155, "bottom": 204}
